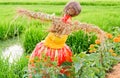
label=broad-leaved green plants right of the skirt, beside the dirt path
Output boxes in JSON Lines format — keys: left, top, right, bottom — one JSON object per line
{"left": 73, "top": 52, "right": 119, "bottom": 78}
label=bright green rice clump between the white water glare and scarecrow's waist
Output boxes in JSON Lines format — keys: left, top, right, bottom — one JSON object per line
{"left": 23, "top": 26, "right": 46, "bottom": 53}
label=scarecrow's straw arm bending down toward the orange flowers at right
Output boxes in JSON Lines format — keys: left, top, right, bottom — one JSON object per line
{"left": 73, "top": 22, "right": 105, "bottom": 41}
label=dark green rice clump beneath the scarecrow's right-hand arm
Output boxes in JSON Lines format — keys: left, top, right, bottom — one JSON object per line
{"left": 67, "top": 31, "right": 96, "bottom": 53}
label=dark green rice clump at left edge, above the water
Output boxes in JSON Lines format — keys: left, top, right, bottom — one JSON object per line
{"left": 0, "top": 22, "right": 24, "bottom": 40}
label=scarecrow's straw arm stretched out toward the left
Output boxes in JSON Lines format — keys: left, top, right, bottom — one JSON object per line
{"left": 17, "top": 9, "right": 58, "bottom": 21}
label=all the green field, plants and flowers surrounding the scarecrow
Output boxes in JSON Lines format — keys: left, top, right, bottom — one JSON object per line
{"left": 0, "top": 0, "right": 120, "bottom": 78}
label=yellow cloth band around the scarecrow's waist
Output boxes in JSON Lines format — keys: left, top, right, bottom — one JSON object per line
{"left": 44, "top": 33, "right": 68, "bottom": 49}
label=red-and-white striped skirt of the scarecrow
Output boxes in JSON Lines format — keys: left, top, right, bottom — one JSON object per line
{"left": 31, "top": 41, "right": 72, "bottom": 66}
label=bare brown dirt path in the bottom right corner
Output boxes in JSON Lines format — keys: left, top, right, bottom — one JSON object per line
{"left": 106, "top": 63, "right": 120, "bottom": 78}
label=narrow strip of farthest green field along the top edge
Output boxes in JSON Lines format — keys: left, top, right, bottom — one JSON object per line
{"left": 0, "top": 0, "right": 120, "bottom": 6}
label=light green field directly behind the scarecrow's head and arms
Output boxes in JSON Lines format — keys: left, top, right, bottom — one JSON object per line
{"left": 0, "top": 5, "right": 120, "bottom": 32}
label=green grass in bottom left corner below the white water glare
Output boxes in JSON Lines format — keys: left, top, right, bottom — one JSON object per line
{"left": 0, "top": 55, "right": 28, "bottom": 78}
